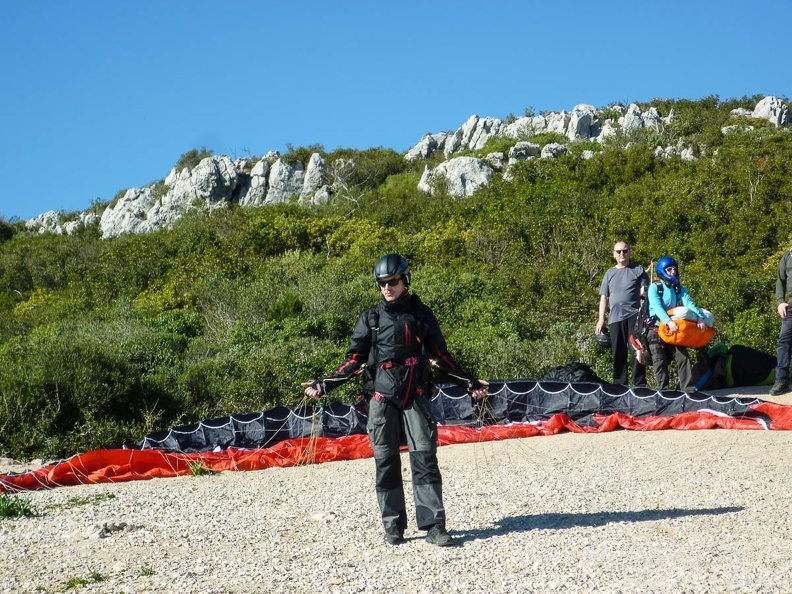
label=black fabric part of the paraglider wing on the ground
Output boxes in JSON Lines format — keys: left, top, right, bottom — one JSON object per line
{"left": 133, "top": 379, "right": 772, "bottom": 452}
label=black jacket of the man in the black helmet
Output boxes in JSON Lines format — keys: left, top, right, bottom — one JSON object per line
{"left": 321, "top": 293, "right": 480, "bottom": 408}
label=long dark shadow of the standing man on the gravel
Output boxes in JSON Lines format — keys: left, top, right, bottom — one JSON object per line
{"left": 452, "top": 507, "right": 745, "bottom": 544}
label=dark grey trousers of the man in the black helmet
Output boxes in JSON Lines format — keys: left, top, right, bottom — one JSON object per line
{"left": 367, "top": 396, "right": 445, "bottom": 533}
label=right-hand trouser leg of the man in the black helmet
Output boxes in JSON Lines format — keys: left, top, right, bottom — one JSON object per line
{"left": 403, "top": 396, "right": 446, "bottom": 530}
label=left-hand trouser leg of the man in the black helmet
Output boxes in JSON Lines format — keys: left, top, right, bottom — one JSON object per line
{"left": 367, "top": 398, "right": 407, "bottom": 532}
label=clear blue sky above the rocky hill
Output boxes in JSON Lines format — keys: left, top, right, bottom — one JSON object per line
{"left": 0, "top": 0, "right": 792, "bottom": 219}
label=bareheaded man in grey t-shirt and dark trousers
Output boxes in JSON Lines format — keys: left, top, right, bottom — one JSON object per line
{"left": 596, "top": 241, "right": 649, "bottom": 386}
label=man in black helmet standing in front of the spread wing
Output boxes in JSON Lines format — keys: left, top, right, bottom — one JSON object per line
{"left": 302, "top": 254, "right": 488, "bottom": 547}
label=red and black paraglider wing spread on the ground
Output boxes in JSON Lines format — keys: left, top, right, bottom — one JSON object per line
{"left": 0, "top": 379, "right": 792, "bottom": 492}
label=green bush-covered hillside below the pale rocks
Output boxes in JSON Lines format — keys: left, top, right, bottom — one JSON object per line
{"left": 0, "top": 97, "right": 792, "bottom": 459}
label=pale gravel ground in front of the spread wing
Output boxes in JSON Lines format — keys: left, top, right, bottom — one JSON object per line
{"left": 0, "top": 388, "right": 792, "bottom": 594}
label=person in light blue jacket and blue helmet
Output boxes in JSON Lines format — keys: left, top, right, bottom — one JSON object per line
{"left": 647, "top": 256, "right": 705, "bottom": 392}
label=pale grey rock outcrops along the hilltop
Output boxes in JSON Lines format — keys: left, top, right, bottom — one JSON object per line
{"left": 26, "top": 96, "right": 790, "bottom": 238}
